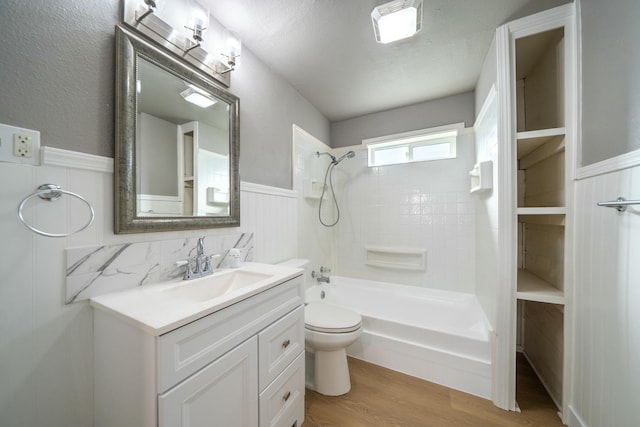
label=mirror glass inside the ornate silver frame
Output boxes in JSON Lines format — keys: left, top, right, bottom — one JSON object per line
{"left": 136, "top": 58, "right": 230, "bottom": 216}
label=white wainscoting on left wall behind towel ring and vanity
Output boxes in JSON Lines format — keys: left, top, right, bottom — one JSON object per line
{"left": 0, "top": 147, "right": 297, "bottom": 426}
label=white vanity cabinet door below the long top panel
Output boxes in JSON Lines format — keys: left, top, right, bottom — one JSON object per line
{"left": 158, "top": 337, "right": 258, "bottom": 427}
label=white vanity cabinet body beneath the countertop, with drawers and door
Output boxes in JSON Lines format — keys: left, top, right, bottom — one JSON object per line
{"left": 94, "top": 276, "right": 304, "bottom": 427}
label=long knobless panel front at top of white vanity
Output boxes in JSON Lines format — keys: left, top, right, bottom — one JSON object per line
{"left": 157, "top": 276, "right": 303, "bottom": 393}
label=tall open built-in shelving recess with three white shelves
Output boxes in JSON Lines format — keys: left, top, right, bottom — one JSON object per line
{"left": 513, "top": 17, "right": 571, "bottom": 418}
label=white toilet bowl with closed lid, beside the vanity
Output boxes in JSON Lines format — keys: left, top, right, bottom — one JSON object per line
{"left": 304, "top": 302, "right": 362, "bottom": 396}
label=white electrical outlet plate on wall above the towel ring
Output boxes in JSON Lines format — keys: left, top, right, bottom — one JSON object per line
{"left": 0, "top": 123, "right": 40, "bottom": 165}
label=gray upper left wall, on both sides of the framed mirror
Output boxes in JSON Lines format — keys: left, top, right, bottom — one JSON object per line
{"left": 0, "top": 0, "right": 330, "bottom": 188}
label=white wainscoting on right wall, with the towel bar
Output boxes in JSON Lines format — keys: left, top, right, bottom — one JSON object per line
{"left": 569, "top": 160, "right": 640, "bottom": 427}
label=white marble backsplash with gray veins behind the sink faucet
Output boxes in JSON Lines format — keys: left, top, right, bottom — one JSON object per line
{"left": 66, "top": 233, "right": 253, "bottom": 304}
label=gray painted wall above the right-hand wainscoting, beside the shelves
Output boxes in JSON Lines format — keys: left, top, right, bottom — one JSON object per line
{"left": 581, "top": 0, "right": 640, "bottom": 166}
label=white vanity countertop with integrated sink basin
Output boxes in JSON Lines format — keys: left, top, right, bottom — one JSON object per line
{"left": 90, "top": 262, "right": 303, "bottom": 336}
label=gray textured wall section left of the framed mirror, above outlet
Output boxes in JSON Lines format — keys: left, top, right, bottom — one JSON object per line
{"left": 0, "top": 0, "right": 121, "bottom": 157}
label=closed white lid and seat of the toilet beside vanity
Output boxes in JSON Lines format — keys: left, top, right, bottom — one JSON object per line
{"left": 304, "top": 303, "right": 362, "bottom": 333}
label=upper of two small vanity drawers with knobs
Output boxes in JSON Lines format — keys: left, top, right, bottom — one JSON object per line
{"left": 258, "top": 306, "right": 304, "bottom": 390}
